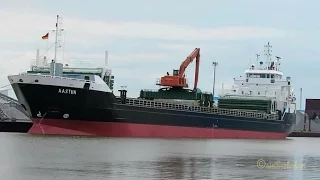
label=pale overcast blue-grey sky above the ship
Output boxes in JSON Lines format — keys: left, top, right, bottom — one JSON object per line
{"left": 0, "top": 0, "right": 320, "bottom": 109}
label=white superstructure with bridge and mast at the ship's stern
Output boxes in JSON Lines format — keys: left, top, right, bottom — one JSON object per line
{"left": 221, "top": 43, "right": 295, "bottom": 112}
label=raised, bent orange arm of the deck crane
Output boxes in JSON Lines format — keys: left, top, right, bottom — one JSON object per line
{"left": 179, "top": 48, "right": 200, "bottom": 89}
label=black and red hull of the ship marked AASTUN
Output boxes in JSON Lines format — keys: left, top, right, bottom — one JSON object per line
{"left": 9, "top": 76, "right": 295, "bottom": 139}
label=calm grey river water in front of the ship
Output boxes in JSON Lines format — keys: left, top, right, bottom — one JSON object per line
{"left": 0, "top": 134, "right": 320, "bottom": 180}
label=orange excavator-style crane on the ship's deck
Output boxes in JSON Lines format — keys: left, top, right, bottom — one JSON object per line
{"left": 158, "top": 48, "right": 200, "bottom": 90}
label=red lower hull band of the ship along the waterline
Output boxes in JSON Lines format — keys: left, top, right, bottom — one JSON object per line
{"left": 28, "top": 118, "right": 287, "bottom": 139}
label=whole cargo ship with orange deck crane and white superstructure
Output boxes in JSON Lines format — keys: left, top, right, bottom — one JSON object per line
{"left": 8, "top": 15, "right": 296, "bottom": 139}
